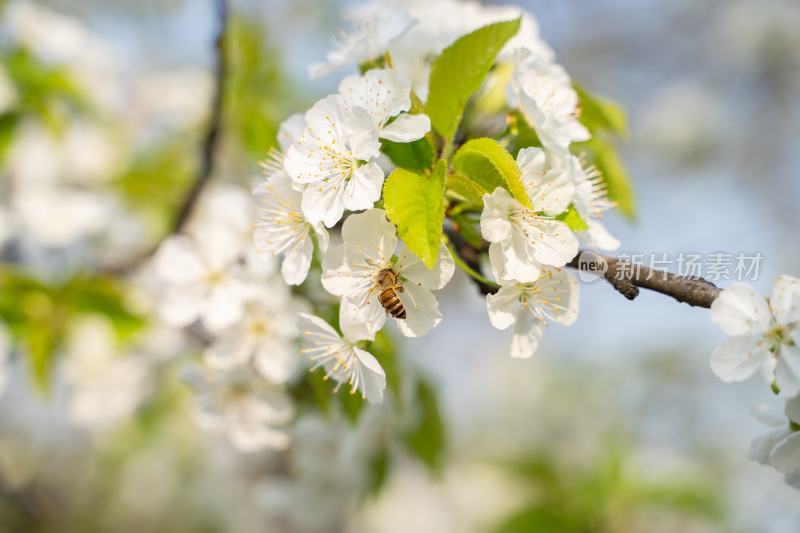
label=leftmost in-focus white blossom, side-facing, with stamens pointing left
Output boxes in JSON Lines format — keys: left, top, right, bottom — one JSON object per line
{"left": 253, "top": 171, "right": 328, "bottom": 285}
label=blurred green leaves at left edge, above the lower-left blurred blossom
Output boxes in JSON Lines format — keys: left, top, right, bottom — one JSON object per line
{"left": 0, "top": 269, "right": 145, "bottom": 390}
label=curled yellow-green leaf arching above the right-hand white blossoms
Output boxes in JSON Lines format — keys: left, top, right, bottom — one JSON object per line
{"left": 453, "top": 137, "right": 531, "bottom": 207}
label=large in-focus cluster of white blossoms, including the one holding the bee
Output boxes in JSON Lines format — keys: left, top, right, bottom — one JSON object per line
{"left": 262, "top": 0, "right": 619, "bottom": 384}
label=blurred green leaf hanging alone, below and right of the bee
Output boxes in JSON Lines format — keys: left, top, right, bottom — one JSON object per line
{"left": 405, "top": 378, "right": 446, "bottom": 473}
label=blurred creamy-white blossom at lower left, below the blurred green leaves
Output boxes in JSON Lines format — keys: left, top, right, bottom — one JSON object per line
{"left": 63, "top": 317, "right": 148, "bottom": 428}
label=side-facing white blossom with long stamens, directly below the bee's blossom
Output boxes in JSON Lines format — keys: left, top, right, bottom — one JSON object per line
{"left": 299, "top": 313, "right": 386, "bottom": 403}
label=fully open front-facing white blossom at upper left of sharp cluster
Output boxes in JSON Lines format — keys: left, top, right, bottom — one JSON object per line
{"left": 284, "top": 95, "right": 383, "bottom": 227}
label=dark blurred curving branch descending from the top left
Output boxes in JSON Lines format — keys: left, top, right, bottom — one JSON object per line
{"left": 100, "top": 0, "right": 228, "bottom": 275}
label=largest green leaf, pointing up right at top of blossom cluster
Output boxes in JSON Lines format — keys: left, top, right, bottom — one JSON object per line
{"left": 426, "top": 19, "right": 520, "bottom": 143}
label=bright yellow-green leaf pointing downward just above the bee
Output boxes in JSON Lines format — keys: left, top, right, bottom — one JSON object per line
{"left": 383, "top": 160, "right": 447, "bottom": 268}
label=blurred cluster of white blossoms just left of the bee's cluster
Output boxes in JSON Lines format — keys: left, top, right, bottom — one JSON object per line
{"left": 153, "top": 186, "right": 300, "bottom": 451}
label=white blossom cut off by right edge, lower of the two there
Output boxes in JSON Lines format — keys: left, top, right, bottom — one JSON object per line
{"left": 748, "top": 396, "right": 800, "bottom": 489}
